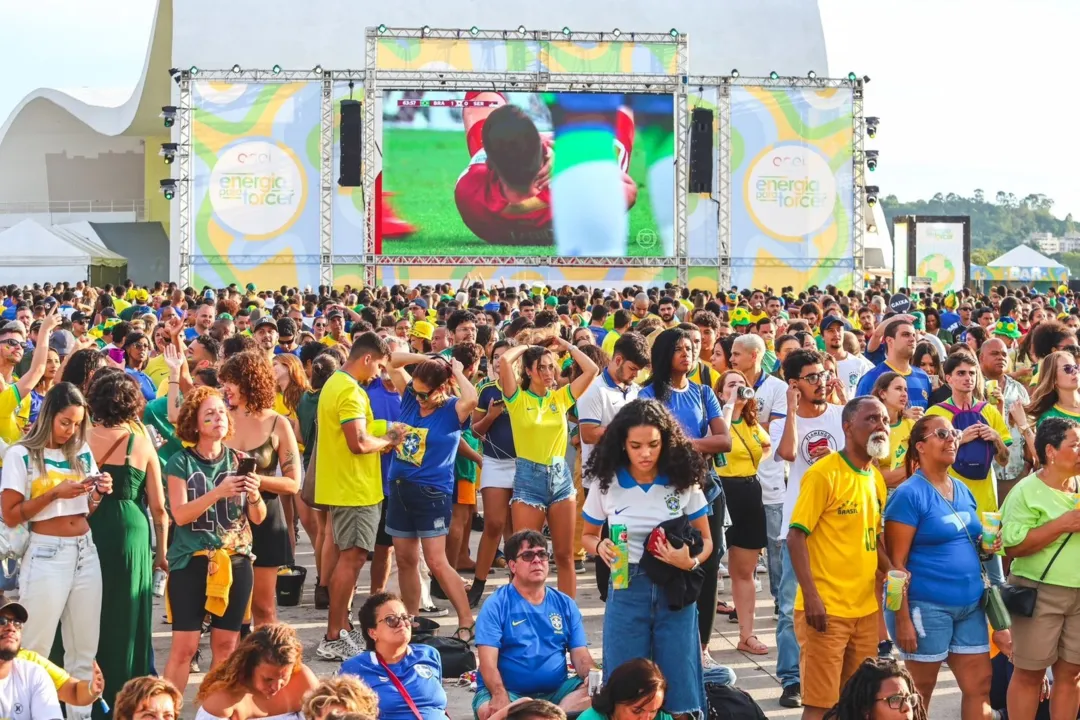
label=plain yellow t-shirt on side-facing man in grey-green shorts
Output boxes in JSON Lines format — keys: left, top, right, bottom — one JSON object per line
{"left": 315, "top": 370, "right": 382, "bottom": 507}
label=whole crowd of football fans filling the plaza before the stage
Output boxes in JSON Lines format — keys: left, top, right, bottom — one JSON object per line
{"left": 0, "top": 275, "right": 1080, "bottom": 720}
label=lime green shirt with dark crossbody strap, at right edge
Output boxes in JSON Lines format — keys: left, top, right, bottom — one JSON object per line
{"left": 1001, "top": 473, "right": 1080, "bottom": 587}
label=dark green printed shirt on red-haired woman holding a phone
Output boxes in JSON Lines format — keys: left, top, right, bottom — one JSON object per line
{"left": 165, "top": 448, "right": 252, "bottom": 570}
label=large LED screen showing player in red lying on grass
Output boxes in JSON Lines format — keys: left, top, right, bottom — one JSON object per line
{"left": 378, "top": 91, "right": 675, "bottom": 257}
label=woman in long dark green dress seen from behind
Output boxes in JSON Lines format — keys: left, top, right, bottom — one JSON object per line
{"left": 86, "top": 369, "right": 168, "bottom": 716}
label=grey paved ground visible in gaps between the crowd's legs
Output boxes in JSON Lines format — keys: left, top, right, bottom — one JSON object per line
{"left": 145, "top": 532, "right": 960, "bottom": 720}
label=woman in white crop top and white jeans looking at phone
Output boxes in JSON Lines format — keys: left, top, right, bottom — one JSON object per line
{"left": 0, "top": 382, "right": 112, "bottom": 719}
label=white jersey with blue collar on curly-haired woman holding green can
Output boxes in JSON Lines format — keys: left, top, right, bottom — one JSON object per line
{"left": 582, "top": 470, "right": 715, "bottom": 562}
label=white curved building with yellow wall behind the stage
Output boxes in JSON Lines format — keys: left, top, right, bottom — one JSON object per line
{"left": 0, "top": 0, "right": 828, "bottom": 281}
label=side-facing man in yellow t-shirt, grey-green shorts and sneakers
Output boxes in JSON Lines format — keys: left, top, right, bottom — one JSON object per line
{"left": 313, "top": 332, "right": 403, "bottom": 661}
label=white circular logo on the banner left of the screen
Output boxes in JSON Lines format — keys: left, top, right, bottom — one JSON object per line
{"left": 210, "top": 140, "right": 303, "bottom": 235}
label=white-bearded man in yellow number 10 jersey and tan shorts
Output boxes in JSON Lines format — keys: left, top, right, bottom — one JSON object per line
{"left": 787, "top": 397, "right": 891, "bottom": 720}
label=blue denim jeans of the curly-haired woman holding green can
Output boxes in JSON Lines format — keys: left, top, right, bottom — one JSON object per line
{"left": 604, "top": 563, "right": 715, "bottom": 716}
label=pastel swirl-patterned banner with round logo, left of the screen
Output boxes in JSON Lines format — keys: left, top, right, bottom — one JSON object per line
{"left": 191, "top": 81, "right": 322, "bottom": 288}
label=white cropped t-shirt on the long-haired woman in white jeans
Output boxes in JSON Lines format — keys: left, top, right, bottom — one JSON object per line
{"left": 0, "top": 444, "right": 97, "bottom": 520}
